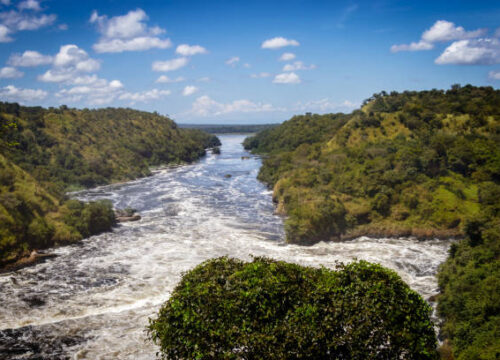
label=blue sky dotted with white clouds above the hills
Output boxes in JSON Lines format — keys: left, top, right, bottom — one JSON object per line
{"left": 0, "top": 0, "right": 500, "bottom": 123}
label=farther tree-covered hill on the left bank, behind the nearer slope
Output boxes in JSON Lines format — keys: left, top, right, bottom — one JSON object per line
{"left": 0, "top": 103, "right": 220, "bottom": 192}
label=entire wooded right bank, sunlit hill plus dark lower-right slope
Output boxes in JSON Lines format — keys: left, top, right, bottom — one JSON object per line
{"left": 244, "top": 85, "right": 500, "bottom": 359}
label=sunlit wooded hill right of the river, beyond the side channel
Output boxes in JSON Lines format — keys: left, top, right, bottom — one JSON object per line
{"left": 245, "top": 86, "right": 500, "bottom": 243}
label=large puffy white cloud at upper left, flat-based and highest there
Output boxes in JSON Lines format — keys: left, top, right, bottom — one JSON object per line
{"left": 90, "top": 9, "right": 172, "bottom": 53}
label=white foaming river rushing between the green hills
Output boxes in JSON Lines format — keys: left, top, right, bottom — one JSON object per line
{"left": 0, "top": 135, "right": 450, "bottom": 359}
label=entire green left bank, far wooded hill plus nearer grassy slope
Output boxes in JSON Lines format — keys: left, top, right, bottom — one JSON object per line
{"left": 0, "top": 103, "right": 220, "bottom": 266}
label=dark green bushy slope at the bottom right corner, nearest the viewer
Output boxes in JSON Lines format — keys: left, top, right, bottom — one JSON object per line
{"left": 438, "top": 190, "right": 500, "bottom": 360}
